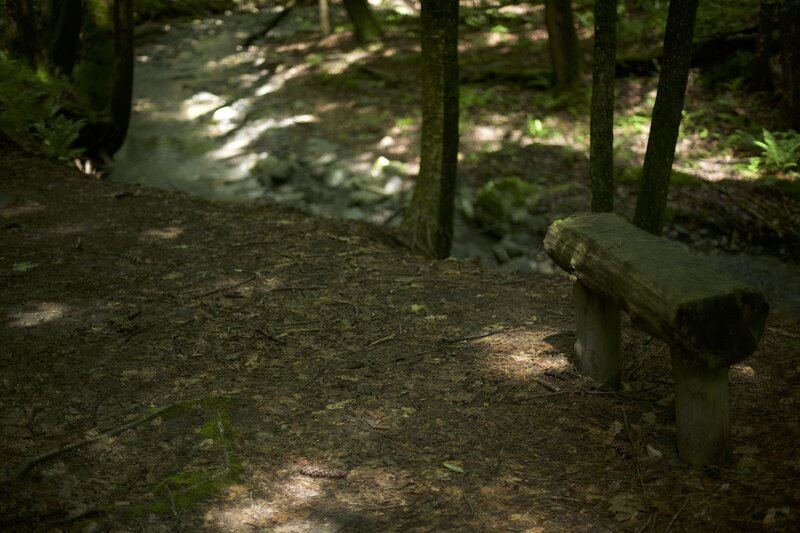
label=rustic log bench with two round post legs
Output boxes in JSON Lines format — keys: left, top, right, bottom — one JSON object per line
{"left": 544, "top": 213, "right": 769, "bottom": 467}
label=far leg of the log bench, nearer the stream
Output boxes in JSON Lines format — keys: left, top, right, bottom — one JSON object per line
{"left": 573, "top": 281, "right": 622, "bottom": 389}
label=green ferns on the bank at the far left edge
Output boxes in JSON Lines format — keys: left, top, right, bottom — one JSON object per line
{"left": 0, "top": 51, "right": 85, "bottom": 159}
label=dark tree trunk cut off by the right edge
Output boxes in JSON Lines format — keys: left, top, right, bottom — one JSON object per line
{"left": 780, "top": 0, "right": 800, "bottom": 132}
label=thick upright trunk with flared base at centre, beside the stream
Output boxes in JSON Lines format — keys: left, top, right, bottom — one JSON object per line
{"left": 402, "top": 0, "right": 458, "bottom": 259}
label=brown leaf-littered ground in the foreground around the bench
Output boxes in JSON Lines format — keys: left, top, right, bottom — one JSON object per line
{"left": 0, "top": 142, "right": 800, "bottom": 532}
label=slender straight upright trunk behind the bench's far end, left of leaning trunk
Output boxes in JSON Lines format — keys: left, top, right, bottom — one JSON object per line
{"left": 589, "top": 0, "right": 617, "bottom": 212}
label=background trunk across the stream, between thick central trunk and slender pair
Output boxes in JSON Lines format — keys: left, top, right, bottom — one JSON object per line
{"left": 544, "top": 0, "right": 583, "bottom": 92}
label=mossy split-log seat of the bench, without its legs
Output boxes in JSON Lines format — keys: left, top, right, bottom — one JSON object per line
{"left": 544, "top": 213, "right": 769, "bottom": 368}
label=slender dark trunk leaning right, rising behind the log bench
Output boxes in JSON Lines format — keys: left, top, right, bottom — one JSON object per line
{"left": 634, "top": 0, "right": 698, "bottom": 235}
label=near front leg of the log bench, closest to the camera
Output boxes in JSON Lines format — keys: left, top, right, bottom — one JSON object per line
{"left": 672, "top": 348, "right": 733, "bottom": 467}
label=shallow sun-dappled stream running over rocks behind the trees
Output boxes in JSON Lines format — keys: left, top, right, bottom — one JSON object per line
{"left": 110, "top": 11, "right": 800, "bottom": 317}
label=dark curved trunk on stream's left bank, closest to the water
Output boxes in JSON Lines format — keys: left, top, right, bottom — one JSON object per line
{"left": 104, "top": 0, "right": 133, "bottom": 155}
